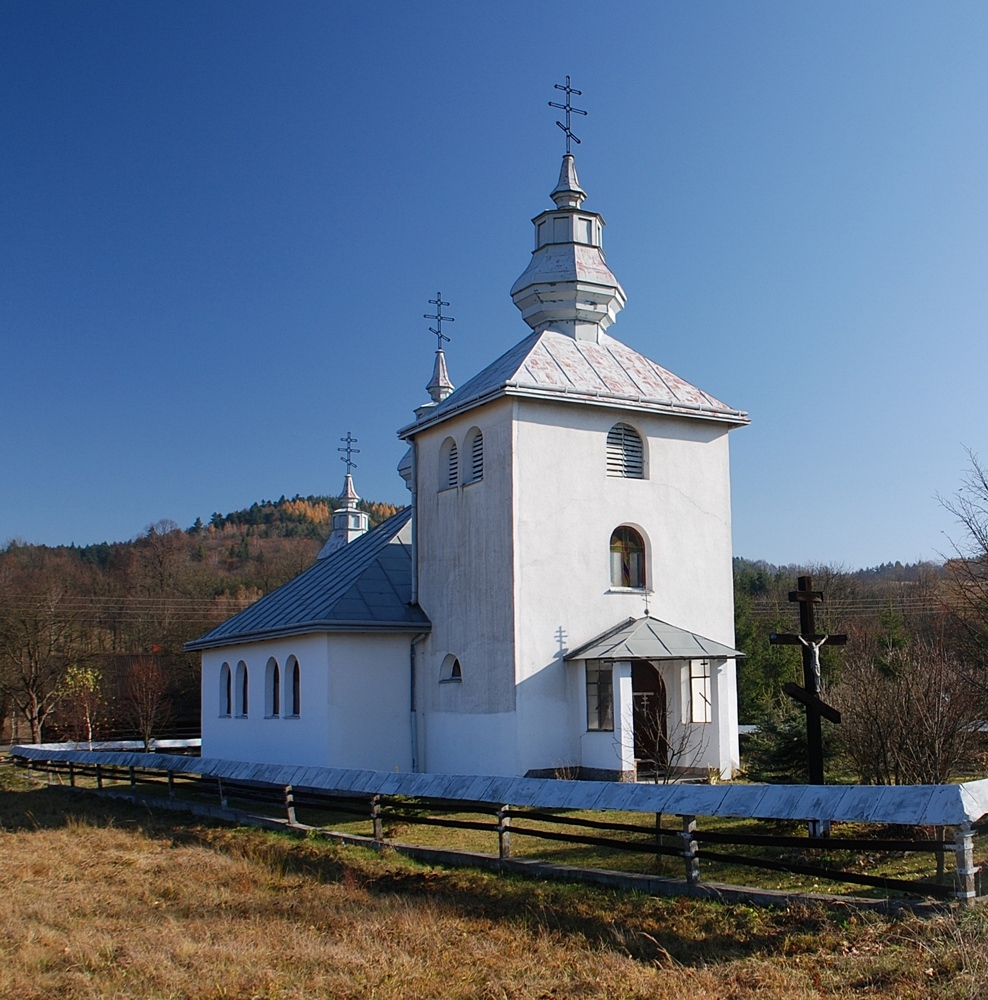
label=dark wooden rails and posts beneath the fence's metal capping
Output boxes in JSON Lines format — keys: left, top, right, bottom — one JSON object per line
{"left": 14, "top": 748, "right": 978, "bottom": 903}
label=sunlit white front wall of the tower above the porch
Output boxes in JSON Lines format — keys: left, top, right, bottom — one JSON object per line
{"left": 513, "top": 399, "right": 734, "bottom": 770}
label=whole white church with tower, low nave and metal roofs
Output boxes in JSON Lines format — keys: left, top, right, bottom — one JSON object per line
{"left": 187, "top": 133, "right": 748, "bottom": 781}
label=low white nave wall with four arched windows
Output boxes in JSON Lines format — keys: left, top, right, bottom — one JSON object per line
{"left": 202, "top": 633, "right": 412, "bottom": 771}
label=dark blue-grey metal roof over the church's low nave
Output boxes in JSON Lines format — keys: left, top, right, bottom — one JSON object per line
{"left": 185, "top": 507, "right": 431, "bottom": 650}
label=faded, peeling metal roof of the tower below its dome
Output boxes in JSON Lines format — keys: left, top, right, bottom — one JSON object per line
{"left": 399, "top": 331, "right": 748, "bottom": 437}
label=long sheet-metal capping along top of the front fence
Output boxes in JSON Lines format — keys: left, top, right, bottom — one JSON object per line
{"left": 10, "top": 743, "right": 988, "bottom": 826}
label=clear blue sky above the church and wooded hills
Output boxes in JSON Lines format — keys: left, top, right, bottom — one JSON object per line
{"left": 0, "top": 0, "right": 988, "bottom": 568}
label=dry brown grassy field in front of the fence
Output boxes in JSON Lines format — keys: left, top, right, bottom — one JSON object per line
{"left": 0, "top": 766, "right": 988, "bottom": 1000}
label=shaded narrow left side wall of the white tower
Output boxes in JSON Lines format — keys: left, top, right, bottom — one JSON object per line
{"left": 415, "top": 400, "right": 517, "bottom": 774}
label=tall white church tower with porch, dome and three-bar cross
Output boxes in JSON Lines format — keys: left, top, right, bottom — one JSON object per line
{"left": 399, "top": 90, "right": 748, "bottom": 778}
